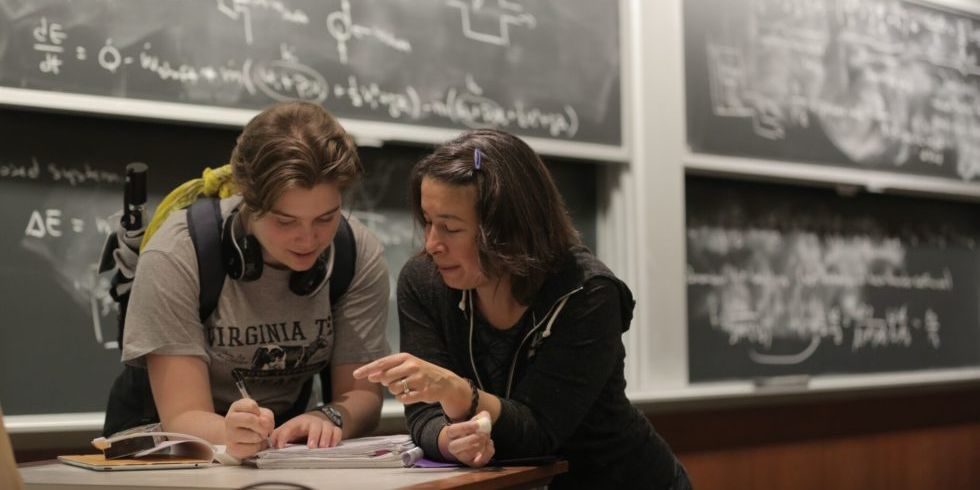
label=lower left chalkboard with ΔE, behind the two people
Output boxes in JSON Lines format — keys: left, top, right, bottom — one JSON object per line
{"left": 0, "top": 109, "right": 598, "bottom": 415}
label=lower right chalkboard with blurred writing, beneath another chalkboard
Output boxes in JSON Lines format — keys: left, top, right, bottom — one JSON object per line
{"left": 686, "top": 177, "right": 980, "bottom": 382}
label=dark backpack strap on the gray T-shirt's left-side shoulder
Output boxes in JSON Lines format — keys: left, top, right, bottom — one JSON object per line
{"left": 187, "top": 197, "right": 225, "bottom": 323}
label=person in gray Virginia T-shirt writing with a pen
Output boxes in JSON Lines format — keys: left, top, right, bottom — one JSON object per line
{"left": 122, "top": 102, "right": 390, "bottom": 458}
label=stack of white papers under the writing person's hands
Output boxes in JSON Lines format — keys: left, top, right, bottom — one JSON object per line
{"left": 250, "top": 434, "right": 422, "bottom": 468}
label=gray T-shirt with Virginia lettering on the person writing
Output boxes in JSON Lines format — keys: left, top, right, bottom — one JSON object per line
{"left": 122, "top": 196, "right": 390, "bottom": 414}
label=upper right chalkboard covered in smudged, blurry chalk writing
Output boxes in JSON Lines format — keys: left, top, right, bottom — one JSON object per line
{"left": 684, "top": 0, "right": 980, "bottom": 182}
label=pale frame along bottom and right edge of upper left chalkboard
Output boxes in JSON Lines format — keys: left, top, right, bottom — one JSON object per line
{"left": 0, "top": 0, "right": 633, "bottom": 163}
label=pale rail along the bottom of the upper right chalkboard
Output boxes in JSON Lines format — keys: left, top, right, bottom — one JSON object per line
{"left": 681, "top": 0, "right": 980, "bottom": 201}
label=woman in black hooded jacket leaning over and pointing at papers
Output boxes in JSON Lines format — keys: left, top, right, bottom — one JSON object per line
{"left": 354, "top": 130, "right": 689, "bottom": 488}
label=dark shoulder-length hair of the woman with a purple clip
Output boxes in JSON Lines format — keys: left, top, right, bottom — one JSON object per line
{"left": 409, "top": 129, "right": 581, "bottom": 305}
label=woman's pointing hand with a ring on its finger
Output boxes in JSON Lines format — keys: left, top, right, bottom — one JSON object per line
{"left": 354, "top": 352, "right": 469, "bottom": 406}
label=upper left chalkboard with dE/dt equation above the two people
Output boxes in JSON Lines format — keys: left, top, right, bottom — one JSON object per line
{"left": 0, "top": 0, "right": 622, "bottom": 155}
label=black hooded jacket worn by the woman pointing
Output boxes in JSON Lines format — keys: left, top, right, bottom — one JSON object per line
{"left": 398, "top": 247, "right": 677, "bottom": 488}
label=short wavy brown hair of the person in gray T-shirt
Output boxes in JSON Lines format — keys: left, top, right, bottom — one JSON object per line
{"left": 231, "top": 102, "right": 363, "bottom": 215}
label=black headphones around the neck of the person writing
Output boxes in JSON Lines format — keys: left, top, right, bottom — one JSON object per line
{"left": 221, "top": 209, "right": 333, "bottom": 296}
